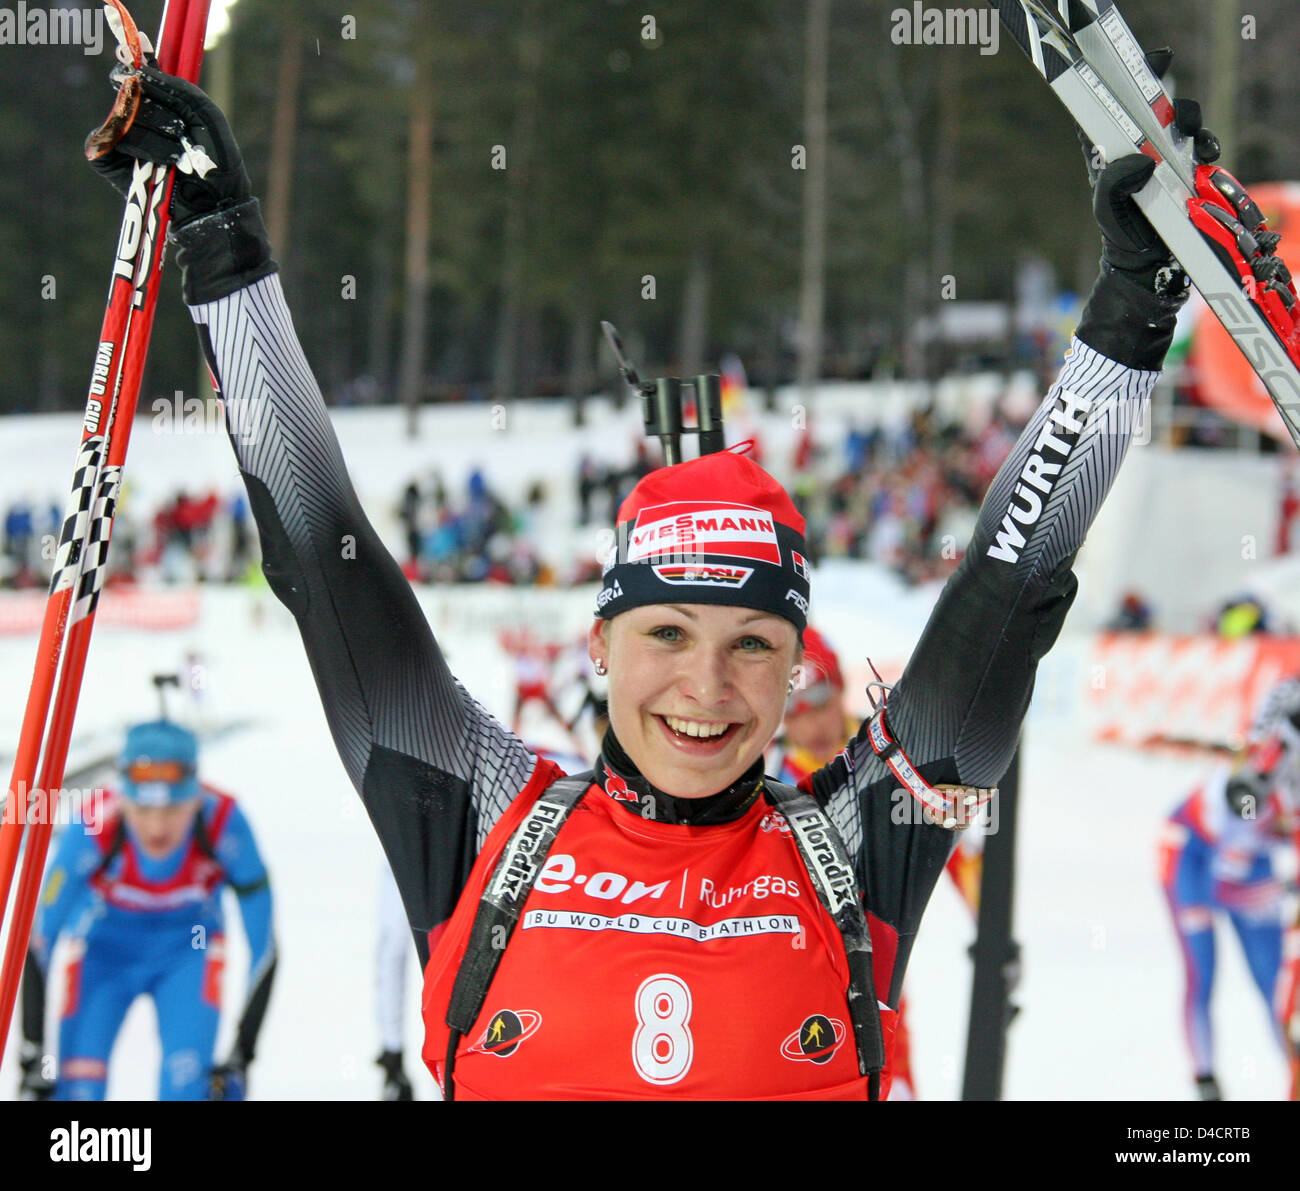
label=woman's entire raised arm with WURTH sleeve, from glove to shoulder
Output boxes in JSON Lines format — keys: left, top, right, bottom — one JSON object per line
{"left": 814, "top": 146, "right": 1187, "bottom": 1005}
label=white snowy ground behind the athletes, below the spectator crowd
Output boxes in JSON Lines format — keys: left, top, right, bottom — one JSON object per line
{"left": 0, "top": 573, "right": 1284, "bottom": 1100}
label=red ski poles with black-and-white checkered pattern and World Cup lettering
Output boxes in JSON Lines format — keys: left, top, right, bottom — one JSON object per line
{"left": 0, "top": 0, "right": 209, "bottom": 1058}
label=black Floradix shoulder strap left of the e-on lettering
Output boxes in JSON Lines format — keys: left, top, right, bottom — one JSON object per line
{"left": 447, "top": 771, "right": 595, "bottom": 1034}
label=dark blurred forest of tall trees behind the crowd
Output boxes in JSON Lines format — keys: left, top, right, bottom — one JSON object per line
{"left": 0, "top": 0, "right": 1300, "bottom": 423}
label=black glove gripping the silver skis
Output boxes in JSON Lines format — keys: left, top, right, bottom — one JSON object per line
{"left": 1075, "top": 49, "right": 1219, "bottom": 371}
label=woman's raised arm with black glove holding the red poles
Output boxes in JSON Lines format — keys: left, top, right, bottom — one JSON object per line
{"left": 95, "top": 68, "right": 536, "bottom": 939}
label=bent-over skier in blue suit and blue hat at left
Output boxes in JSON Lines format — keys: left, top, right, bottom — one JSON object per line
{"left": 21, "top": 719, "right": 276, "bottom": 1100}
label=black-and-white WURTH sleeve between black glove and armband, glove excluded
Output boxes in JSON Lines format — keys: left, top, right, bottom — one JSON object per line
{"left": 887, "top": 326, "right": 1158, "bottom": 787}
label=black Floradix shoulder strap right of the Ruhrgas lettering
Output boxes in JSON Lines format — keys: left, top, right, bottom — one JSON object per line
{"left": 763, "top": 780, "right": 885, "bottom": 1100}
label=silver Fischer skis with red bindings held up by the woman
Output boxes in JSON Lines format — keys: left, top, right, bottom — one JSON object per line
{"left": 989, "top": 0, "right": 1300, "bottom": 447}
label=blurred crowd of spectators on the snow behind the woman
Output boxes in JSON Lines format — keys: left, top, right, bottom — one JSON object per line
{"left": 0, "top": 411, "right": 1034, "bottom": 588}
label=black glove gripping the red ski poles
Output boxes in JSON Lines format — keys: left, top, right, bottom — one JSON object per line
{"left": 91, "top": 64, "right": 278, "bottom": 306}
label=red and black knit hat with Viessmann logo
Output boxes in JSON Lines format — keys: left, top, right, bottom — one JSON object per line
{"left": 595, "top": 443, "right": 809, "bottom": 632}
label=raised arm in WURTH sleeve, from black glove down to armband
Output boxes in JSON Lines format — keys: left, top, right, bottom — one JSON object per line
{"left": 887, "top": 155, "right": 1187, "bottom": 787}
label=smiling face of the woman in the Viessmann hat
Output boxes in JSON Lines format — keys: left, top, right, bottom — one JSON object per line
{"left": 588, "top": 603, "right": 801, "bottom": 798}
